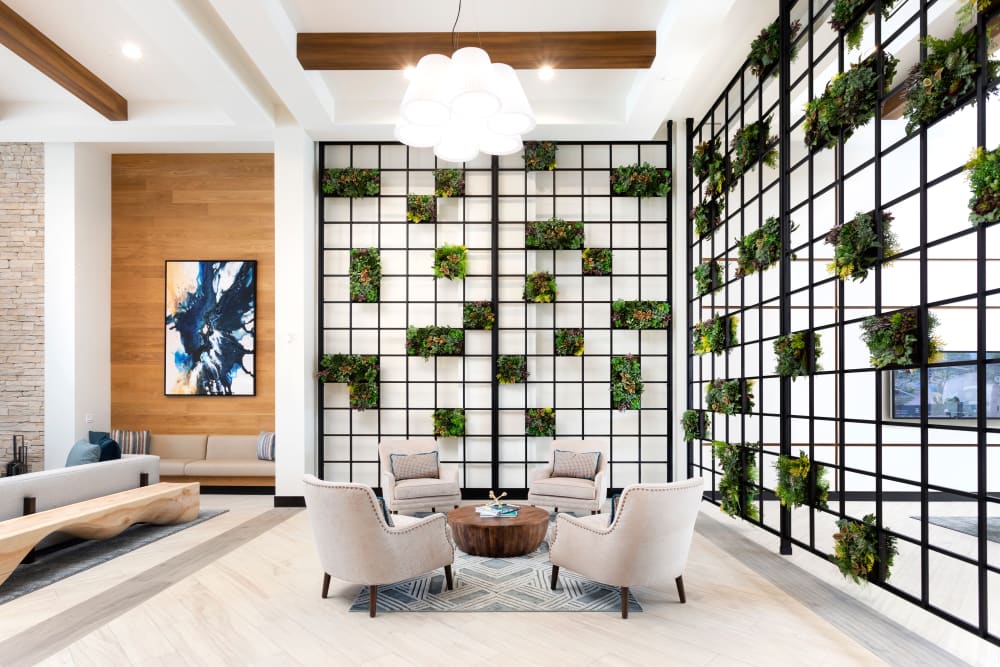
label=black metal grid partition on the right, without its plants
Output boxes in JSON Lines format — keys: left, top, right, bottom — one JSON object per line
{"left": 685, "top": 0, "right": 1000, "bottom": 644}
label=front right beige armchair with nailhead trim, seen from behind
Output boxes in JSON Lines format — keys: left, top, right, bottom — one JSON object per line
{"left": 549, "top": 477, "right": 702, "bottom": 618}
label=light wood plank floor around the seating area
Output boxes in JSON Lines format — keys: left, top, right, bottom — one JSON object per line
{"left": 0, "top": 496, "right": 997, "bottom": 667}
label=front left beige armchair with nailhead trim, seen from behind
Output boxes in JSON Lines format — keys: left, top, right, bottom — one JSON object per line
{"left": 303, "top": 475, "right": 455, "bottom": 617}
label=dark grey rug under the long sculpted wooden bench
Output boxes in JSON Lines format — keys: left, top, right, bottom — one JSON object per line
{"left": 0, "top": 510, "right": 228, "bottom": 604}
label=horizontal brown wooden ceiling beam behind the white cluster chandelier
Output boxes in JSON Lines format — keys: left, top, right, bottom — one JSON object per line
{"left": 298, "top": 30, "right": 656, "bottom": 70}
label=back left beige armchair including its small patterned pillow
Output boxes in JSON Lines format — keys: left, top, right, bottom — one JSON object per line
{"left": 378, "top": 438, "right": 462, "bottom": 512}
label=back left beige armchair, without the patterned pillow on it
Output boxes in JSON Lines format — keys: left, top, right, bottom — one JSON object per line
{"left": 378, "top": 438, "right": 462, "bottom": 512}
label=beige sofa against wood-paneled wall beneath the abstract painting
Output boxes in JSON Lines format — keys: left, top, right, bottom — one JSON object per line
{"left": 149, "top": 433, "right": 274, "bottom": 486}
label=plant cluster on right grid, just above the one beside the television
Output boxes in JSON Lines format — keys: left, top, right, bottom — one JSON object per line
{"left": 826, "top": 211, "right": 899, "bottom": 281}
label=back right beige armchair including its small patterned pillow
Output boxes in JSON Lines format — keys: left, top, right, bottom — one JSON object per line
{"left": 528, "top": 440, "right": 609, "bottom": 514}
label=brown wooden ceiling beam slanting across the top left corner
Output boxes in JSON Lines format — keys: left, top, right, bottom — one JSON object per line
{"left": 0, "top": 1, "right": 128, "bottom": 120}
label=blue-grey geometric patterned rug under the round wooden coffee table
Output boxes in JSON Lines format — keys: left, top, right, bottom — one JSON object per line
{"left": 351, "top": 542, "right": 642, "bottom": 613}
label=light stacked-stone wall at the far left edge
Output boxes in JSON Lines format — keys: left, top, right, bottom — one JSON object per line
{"left": 0, "top": 143, "right": 45, "bottom": 475}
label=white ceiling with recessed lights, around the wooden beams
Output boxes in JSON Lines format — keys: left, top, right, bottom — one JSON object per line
{"left": 0, "top": 0, "right": 778, "bottom": 151}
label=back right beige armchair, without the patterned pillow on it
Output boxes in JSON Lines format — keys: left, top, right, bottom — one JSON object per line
{"left": 528, "top": 440, "right": 609, "bottom": 514}
